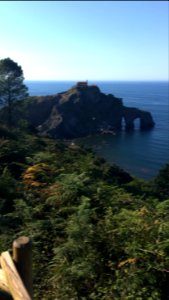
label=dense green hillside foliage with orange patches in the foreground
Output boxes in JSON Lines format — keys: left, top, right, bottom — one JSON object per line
{"left": 0, "top": 123, "right": 169, "bottom": 300}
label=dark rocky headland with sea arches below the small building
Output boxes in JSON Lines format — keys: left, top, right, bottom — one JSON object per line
{"left": 0, "top": 86, "right": 154, "bottom": 139}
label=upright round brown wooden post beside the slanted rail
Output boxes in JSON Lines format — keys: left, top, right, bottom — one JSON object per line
{"left": 13, "top": 236, "right": 33, "bottom": 299}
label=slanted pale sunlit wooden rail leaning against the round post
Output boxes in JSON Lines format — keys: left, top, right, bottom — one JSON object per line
{"left": 1, "top": 251, "right": 31, "bottom": 300}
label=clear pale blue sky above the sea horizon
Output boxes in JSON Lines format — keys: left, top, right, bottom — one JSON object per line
{"left": 0, "top": 1, "right": 169, "bottom": 80}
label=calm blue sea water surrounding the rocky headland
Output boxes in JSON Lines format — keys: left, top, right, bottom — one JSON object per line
{"left": 25, "top": 81, "right": 169, "bottom": 180}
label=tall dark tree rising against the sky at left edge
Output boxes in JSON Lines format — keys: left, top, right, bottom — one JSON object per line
{"left": 0, "top": 58, "right": 28, "bottom": 124}
